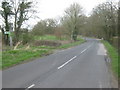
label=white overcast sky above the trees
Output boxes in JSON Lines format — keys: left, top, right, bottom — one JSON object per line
{"left": 0, "top": 0, "right": 118, "bottom": 26}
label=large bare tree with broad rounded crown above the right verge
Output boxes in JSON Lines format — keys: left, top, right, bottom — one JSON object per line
{"left": 90, "top": 2, "right": 117, "bottom": 43}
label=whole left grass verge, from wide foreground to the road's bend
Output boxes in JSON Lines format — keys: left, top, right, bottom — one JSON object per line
{"left": 2, "top": 36, "right": 84, "bottom": 69}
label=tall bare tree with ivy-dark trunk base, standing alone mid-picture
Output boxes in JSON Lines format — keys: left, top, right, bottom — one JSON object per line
{"left": 62, "top": 3, "right": 82, "bottom": 41}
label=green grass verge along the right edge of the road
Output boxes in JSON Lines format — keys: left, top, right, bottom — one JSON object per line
{"left": 102, "top": 41, "right": 120, "bottom": 78}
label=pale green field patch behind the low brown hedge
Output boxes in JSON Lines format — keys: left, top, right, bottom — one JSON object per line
{"left": 35, "top": 35, "right": 67, "bottom": 40}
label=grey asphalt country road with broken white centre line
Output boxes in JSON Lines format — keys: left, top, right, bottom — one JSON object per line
{"left": 2, "top": 39, "right": 111, "bottom": 89}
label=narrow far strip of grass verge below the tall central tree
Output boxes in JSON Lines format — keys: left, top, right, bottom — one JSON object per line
{"left": 58, "top": 38, "right": 85, "bottom": 49}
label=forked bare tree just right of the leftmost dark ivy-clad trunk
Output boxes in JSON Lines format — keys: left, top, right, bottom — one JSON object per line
{"left": 12, "top": 0, "right": 35, "bottom": 43}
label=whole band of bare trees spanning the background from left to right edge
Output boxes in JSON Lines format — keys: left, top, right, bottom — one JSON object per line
{"left": 1, "top": 0, "right": 120, "bottom": 50}
